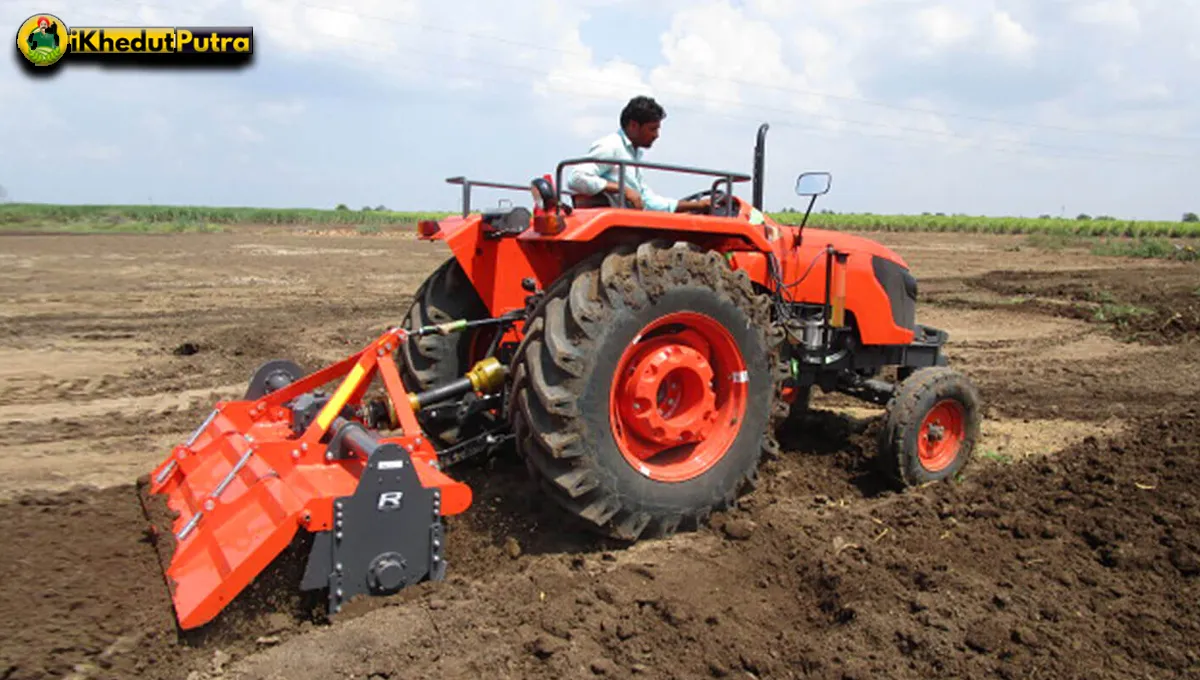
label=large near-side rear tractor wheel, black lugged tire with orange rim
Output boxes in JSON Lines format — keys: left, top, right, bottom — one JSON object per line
{"left": 510, "top": 241, "right": 787, "bottom": 541}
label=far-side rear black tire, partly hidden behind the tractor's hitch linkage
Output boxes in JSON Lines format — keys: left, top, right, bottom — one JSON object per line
{"left": 397, "top": 257, "right": 491, "bottom": 446}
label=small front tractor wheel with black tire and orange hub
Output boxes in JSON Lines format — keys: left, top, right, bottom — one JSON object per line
{"left": 878, "top": 366, "right": 980, "bottom": 488}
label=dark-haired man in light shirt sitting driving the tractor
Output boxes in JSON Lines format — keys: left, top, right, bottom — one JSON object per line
{"left": 566, "top": 96, "right": 712, "bottom": 212}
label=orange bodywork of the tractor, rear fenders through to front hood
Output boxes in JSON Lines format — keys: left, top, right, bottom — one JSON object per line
{"left": 420, "top": 201, "right": 914, "bottom": 345}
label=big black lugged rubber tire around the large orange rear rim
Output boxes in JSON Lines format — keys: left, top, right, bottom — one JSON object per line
{"left": 510, "top": 241, "right": 787, "bottom": 541}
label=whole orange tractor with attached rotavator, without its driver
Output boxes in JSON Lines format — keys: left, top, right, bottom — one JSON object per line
{"left": 143, "top": 125, "right": 980, "bottom": 628}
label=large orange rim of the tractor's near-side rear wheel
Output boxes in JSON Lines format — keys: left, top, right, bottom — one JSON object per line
{"left": 608, "top": 312, "right": 749, "bottom": 482}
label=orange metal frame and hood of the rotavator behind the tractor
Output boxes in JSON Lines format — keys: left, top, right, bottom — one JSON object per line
{"left": 144, "top": 329, "right": 472, "bottom": 628}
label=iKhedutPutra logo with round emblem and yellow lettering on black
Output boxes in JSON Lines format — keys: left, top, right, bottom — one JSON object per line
{"left": 17, "top": 14, "right": 254, "bottom": 66}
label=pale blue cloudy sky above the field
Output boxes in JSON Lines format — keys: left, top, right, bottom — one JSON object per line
{"left": 0, "top": 0, "right": 1200, "bottom": 221}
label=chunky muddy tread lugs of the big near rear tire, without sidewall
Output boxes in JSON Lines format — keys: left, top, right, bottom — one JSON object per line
{"left": 510, "top": 240, "right": 788, "bottom": 541}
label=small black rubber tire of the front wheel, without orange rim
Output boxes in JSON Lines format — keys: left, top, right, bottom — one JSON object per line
{"left": 878, "top": 366, "right": 982, "bottom": 489}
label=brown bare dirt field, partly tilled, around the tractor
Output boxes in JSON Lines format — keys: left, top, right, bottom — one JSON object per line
{"left": 0, "top": 230, "right": 1200, "bottom": 680}
